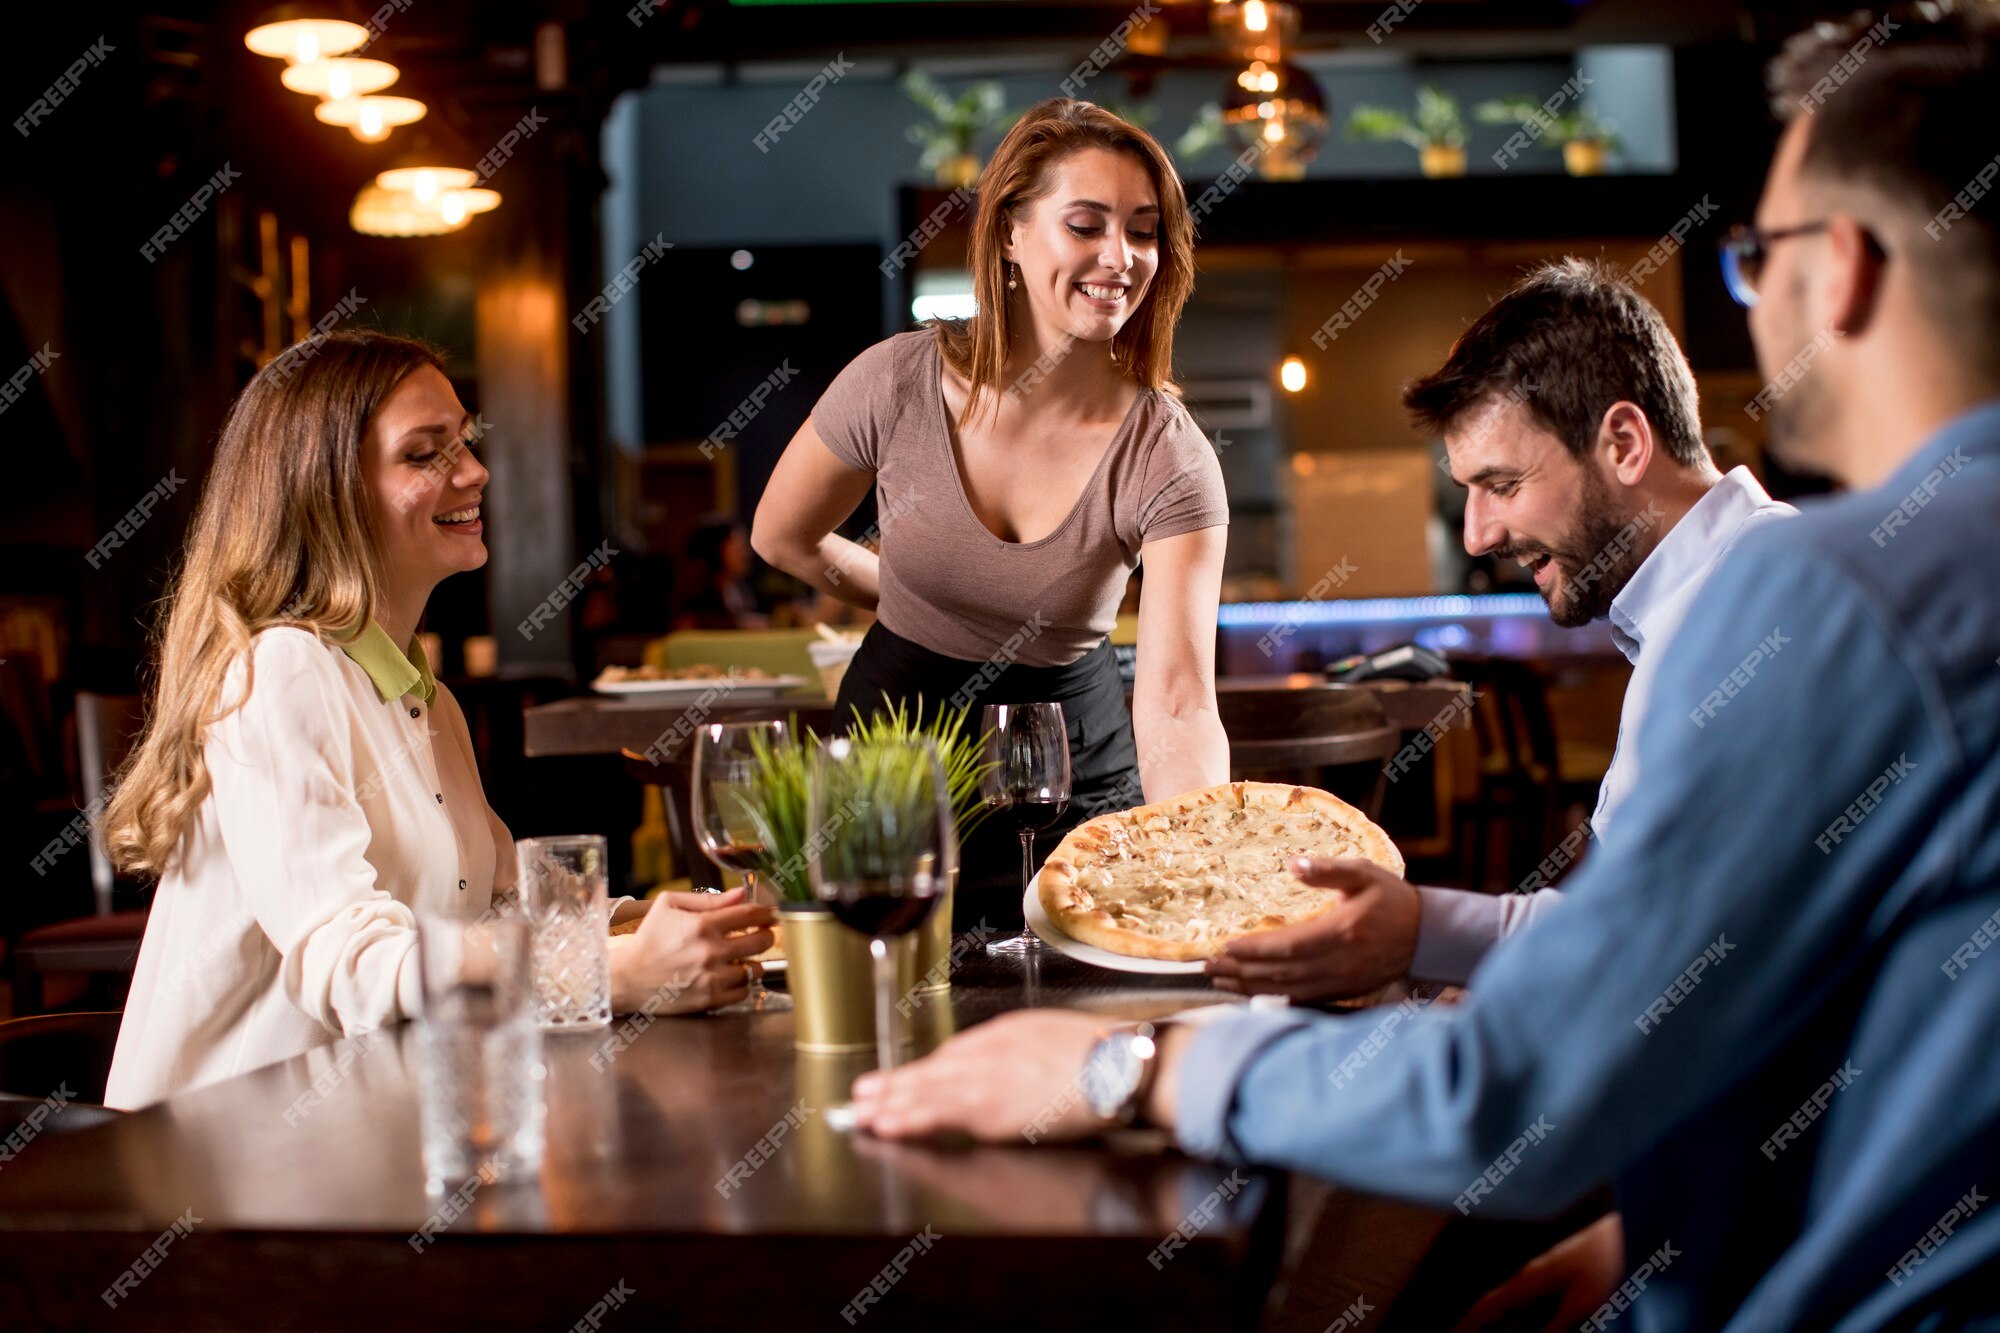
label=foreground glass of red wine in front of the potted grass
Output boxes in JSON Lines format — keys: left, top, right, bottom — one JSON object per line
{"left": 806, "top": 739, "right": 958, "bottom": 1069}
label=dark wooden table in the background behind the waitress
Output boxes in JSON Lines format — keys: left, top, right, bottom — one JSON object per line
{"left": 522, "top": 675, "right": 1466, "bottom": 759}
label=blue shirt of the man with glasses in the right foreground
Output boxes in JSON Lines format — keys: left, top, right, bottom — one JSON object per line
{"left": 1176, "top": 402, "right": 2000, "bottom": 1333}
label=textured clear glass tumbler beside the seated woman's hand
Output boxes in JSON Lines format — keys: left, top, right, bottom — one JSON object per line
{"left": 514, "top": 835, "right": 612, "bottom": 1031}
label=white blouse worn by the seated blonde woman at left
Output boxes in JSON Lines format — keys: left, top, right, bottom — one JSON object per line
{"left": 104, "top": 626, "right": 514, "bottom": 1109}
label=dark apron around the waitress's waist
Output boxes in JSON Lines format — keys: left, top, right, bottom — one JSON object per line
{"left": 834, "top": 620, "right": 1142, "bottom": 933}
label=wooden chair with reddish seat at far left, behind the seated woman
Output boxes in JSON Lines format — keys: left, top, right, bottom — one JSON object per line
{"left": 12, "top": 693, "right": 146, "bottom": 1015}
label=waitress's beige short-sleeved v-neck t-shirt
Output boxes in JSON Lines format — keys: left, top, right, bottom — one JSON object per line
{"left": 812, "top": 328, "right": 1230, "bottom": 667}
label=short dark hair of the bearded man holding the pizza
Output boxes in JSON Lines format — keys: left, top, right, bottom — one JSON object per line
{"left": 1402, "top": 258, "right": 1708, "bottom": 466}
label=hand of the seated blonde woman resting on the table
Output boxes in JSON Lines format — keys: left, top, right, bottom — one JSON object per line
{"left": 610, "top": 889, "right": 778, "bottom": 1013}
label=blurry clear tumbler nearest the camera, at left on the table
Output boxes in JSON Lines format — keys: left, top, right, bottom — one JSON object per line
{"left": 416, "top": 913, "right": 548, "bottom": 1189}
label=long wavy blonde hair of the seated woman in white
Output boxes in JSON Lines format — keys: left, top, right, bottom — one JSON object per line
{"left": 104, "top": 330, "right": 444, "bottom": 877}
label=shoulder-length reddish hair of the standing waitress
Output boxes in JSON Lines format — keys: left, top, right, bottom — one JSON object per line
{"left": 936, "top": 98, "right": 1194, "bottom": 422}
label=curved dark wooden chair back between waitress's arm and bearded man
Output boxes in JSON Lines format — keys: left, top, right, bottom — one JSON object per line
{"left": 1216, "top": 685, "right": 1402, "bottom": 819}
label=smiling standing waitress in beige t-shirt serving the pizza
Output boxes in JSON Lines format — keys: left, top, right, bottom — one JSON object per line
{"left": 752, "top": 98, "right": 1228, "bottom": 929}
